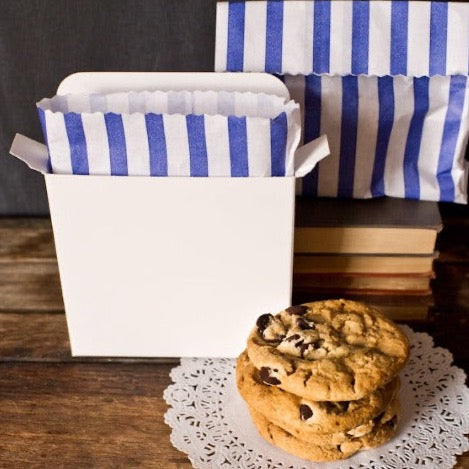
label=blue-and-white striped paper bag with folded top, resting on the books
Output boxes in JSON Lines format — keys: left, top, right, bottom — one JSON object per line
{"left": 215, "top": 0, "right": 469, "bottom": 203}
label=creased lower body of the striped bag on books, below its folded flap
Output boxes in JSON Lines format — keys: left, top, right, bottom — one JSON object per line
{"left": 285, "top": 75, "right": 469, "bottom": 203}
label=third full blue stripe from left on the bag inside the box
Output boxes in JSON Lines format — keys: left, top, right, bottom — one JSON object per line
{"left": 145, "top": 114, "right": 168, "bottom": 176}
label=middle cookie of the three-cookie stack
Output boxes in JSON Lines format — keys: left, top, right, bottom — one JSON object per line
{"left": 236, "top": 352, "right": 399, "bottom": 436}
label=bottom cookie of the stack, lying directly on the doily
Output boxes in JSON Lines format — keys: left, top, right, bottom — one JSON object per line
{"left": 249, "top": 400, "right": 398, "bottom": 462}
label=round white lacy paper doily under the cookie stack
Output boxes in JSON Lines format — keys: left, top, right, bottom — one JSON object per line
{"left": 164, "top": 326, "right": 469, "bottom": 469}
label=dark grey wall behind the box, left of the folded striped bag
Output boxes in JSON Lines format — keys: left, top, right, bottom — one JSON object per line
{"left": 0, "top": 0, "right": 216, "bottom": 215}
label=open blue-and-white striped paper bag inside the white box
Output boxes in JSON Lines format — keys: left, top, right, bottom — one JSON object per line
{"left": 38, "top": 91, "right": 308, "bottom": 177}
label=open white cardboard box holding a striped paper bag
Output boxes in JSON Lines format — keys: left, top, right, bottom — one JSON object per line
{"left": 12, "top": 73, "right": 295, "bottom": 357}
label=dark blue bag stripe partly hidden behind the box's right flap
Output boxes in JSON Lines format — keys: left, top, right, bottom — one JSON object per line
{"left": 303, "top": 75, "right": 322, "bottom": 196}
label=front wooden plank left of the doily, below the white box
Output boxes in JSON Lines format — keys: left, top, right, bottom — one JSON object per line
{"left": 0, "top": 363, "right": 192, "bottom": 469}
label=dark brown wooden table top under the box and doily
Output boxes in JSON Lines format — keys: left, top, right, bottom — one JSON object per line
{"left": 0, "top": 205, "right": 469, "bottom": 469}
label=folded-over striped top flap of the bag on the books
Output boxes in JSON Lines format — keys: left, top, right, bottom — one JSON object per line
{"left": 215, "top": 0, "right": 469, "bottom": 76}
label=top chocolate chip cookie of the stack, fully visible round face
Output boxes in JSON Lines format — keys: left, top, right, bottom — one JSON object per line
{"left": 247, "top": 300, "right": 409, "bottom": 401}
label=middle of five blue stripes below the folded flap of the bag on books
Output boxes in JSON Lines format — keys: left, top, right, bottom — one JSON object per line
{"left": 371, "top": 76, "right": 394, "bottom": 197}
